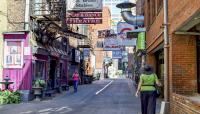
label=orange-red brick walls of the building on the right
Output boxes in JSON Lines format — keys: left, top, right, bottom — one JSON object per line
{"left": 144, "top": 0, "right": 200, "bottom": 114}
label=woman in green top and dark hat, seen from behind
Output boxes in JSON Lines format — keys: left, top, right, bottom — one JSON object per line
{"left": 135, "top": 65, "right": 161, "bottom": 114}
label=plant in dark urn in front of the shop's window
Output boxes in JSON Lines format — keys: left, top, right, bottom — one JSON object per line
{"left": 32, "top": 78, "right": 46, "bottom": 100}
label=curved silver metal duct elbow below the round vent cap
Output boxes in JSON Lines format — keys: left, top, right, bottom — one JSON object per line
{"left": 121, "top": 11, "right": 144, "bottom": 25}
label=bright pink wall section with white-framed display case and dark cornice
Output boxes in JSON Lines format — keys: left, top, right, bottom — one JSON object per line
{"left": 2, "top": 31, "right": 32, "bottom": 90}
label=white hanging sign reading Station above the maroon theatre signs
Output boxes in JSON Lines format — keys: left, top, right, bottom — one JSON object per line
{"left": 66, "top": 0, "right": 103, "bottom": 11}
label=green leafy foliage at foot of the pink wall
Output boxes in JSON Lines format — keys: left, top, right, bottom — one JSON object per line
{"left": 0, "top": 90, "right": 21, "bottom": 104}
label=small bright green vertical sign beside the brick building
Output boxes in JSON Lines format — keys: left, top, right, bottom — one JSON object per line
{"left": 136, "top": 32, "right": 145, "bottom": 50}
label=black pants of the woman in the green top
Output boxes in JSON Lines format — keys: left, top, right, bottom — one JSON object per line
{"left": 140, "top": 91, "right": 156, "bottom": 114}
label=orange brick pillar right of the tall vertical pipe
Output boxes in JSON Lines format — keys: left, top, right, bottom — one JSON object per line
{"left": 169, "top": 35, "right": 197, "bottom": 94}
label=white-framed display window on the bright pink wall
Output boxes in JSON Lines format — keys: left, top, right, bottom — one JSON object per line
{"left": 4, "top": 40, "right": 23, "bottom": 68}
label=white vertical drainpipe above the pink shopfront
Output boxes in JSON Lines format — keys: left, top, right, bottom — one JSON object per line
{"left": 24, "top": 0, "right": 30, "bottom": 31}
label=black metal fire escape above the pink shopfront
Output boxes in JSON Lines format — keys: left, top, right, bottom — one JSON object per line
{"left": 31, "top": 0, "right": 86, "bottom": 43}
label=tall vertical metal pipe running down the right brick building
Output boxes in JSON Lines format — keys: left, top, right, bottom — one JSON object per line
{"left": 163, "top": 0, "right": 169, "bottom": 102}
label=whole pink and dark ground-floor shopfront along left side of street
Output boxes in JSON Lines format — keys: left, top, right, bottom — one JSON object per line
{"left": 1, "top": 31, "right": 68, "bottom": 99}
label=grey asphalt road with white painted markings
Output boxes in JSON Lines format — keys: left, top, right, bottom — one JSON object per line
{"left": 0, "top": 79, "right": 159, "bottom": 114}
